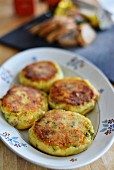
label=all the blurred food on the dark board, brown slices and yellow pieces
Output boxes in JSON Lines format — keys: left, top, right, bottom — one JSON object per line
{"left": 30, "top": 0, "right": 113, "bottom": 47}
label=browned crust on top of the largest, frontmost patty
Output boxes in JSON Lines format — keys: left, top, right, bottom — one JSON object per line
{"left": 33, "top": 110, "right": 91, "bottom": 148}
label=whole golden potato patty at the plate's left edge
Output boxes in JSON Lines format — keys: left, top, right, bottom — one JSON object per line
{"left": 1, "top": 85, "right": 48, "bottom": 129}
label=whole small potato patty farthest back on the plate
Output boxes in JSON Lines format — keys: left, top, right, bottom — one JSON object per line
{"left": 19, "top": 61, "right": 63, "bottom": 92}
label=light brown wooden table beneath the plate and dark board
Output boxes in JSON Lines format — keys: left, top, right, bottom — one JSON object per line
{"left": 0, "top": 0, "right": 114, "bottom": 170}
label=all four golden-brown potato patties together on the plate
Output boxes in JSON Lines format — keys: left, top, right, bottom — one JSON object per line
{"left": 1, "top": 61, "right": 99, "bottom": 156}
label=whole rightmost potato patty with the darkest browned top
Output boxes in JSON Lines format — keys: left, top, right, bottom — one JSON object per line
{"left": 49, "top": 77, "right": 99, "bottom": 115}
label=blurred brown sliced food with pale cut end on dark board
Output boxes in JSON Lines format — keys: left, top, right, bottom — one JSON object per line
{"left": 31, "top": 16, "right": 96, "bottom": 46}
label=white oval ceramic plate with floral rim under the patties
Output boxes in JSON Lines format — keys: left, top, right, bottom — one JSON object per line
{"left": 0, "top": 48, "right": 114, "bottom": 169}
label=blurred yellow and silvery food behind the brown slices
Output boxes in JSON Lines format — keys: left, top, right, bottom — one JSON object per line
{"left": 55, "top": 0, "right": 113, "bottom": 30}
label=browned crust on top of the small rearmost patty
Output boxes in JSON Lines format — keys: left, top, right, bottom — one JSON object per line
{"left": 22, "top": 61, "right": 57, "bottom": 81}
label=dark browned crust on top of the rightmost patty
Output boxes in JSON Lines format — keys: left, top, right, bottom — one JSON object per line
{"left": 50, "top": 78, "right": 95, "bottom": 106}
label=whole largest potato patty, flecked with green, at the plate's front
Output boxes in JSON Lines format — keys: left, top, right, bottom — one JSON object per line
{"left": 29, "top": 109, "right": 94, "bottom": 156}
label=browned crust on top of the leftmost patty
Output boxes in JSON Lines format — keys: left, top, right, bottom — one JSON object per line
{"left": 2, "top": 85, "right": 44, "bottom": 113}
